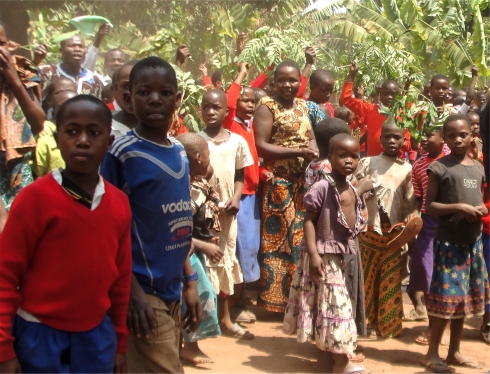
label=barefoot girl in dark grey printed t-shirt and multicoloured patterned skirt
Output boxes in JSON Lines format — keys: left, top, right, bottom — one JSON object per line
{"left": 422, "top": 114, "right": 490, "bottom": 373}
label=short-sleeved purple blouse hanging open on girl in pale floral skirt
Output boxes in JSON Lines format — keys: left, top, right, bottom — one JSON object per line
{"left": 301, "top": 174, "right": 364, "bottom": 255}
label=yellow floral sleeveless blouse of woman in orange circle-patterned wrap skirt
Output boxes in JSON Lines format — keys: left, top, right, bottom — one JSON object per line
{"left": 258, "top": 97, "right": 312, "bottom": 174}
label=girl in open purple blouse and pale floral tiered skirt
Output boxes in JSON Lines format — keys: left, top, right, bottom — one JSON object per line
{"left": 283, "top": 134, "right": 365, "bottom": 373}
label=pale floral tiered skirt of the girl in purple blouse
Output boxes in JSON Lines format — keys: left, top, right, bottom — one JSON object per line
{"left": 283, "top": 251, "right": 357, "bottom": 354}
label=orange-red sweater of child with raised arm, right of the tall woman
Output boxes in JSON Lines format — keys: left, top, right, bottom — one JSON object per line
{"left": 340, "top": 82, "right": 412, "bottom": 158}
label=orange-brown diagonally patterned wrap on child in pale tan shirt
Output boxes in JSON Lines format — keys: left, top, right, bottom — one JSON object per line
{"left": 359, "top": 227, "right": 403, "bottom": 338}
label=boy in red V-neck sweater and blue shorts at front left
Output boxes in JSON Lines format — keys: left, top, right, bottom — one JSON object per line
{"left": 0, "top": 95, "right": 131, "bottom": 373}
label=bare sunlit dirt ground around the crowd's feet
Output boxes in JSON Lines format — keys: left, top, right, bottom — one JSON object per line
{"left": 184, "top": 294, "right": 490, "bottom": 374}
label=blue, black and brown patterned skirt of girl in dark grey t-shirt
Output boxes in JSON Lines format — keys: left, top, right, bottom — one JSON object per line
{"left": 427, "top": 238, "right": 490, "bottom": 319}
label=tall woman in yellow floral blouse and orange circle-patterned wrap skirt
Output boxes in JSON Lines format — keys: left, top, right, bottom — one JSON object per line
{"left": 254, "top": 61, "right": 318, "bottom": 313}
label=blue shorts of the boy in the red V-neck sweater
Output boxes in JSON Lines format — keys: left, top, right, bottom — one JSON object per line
{"left": 13, "top": 315, "right": 117, "bottom": 373}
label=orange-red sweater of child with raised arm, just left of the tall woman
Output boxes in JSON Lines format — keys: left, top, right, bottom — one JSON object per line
{"left": 223, "top": 82, "right": 259, "bottom": 195}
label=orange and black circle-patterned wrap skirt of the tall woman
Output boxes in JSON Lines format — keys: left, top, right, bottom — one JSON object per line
{"left": 257, "top": 176, "right": 306, "bottom": 313}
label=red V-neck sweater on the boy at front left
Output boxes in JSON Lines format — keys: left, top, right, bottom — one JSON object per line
{"left": 0, "top": 174, "right": 131, "bottom": 361}
